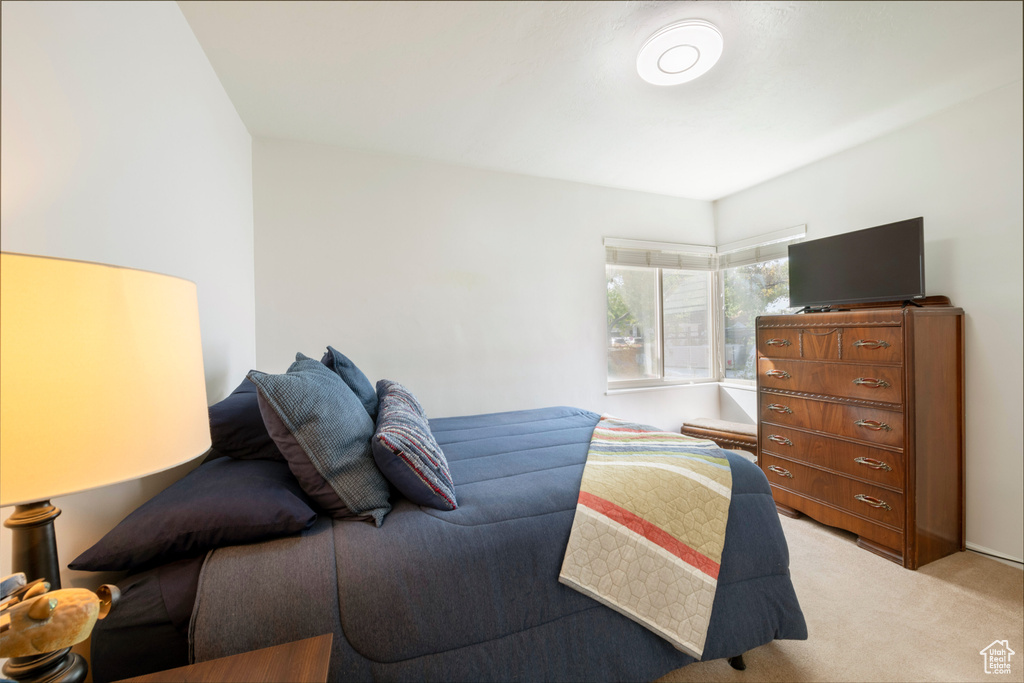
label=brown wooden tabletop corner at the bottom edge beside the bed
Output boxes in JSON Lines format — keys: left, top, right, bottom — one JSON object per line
{"left": 119, "top": 633, "right": 334, "bottom": 683}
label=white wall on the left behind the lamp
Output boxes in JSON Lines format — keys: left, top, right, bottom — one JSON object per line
{"left": 0, "top": 2, "right": 255, "bottom": 587}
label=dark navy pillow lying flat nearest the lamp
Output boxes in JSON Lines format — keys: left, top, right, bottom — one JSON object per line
{"left": 69, "top": 458, "right": 316, "bottom": 571}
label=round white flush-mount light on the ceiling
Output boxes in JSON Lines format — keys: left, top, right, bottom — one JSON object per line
{"left": 637, "top": 19, "right": 724, "bottom": 85}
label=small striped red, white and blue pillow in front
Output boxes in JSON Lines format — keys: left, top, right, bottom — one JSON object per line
{"left": 371, "top": 380, "right": 458, "bottom": 510}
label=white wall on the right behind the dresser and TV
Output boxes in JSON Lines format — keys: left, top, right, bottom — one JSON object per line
{"left": 716, "top": 83, "right": 1024, "bottom": 561}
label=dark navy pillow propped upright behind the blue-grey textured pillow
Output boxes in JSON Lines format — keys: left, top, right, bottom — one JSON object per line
{"left": 210, "top": 379, "right": 285, "bottom": 462}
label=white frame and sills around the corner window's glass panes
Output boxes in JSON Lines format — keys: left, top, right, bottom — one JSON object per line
{"left": 604, "top": 225, "right": 807, "bottom": 393}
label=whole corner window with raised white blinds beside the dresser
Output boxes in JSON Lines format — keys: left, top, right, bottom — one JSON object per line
{"left": 604, "top": 226, "right": 804, "bottom": 388}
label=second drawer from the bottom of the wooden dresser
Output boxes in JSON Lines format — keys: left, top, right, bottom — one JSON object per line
{"left": 760, "top": 424, "right": 903, "bottom": 490}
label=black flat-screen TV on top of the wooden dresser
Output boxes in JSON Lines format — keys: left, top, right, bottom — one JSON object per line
{"left": 790, "top": 218, "right": 925, "bottom": 307}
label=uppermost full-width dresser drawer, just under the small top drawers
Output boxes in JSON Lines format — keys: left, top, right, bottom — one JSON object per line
{"left": 758, "top": 358, "right": 903, "bottom": 403}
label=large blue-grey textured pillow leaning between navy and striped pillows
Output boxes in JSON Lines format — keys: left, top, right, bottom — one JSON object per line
{"left": 249, "top": 353, "right": 391, "bottom": 526}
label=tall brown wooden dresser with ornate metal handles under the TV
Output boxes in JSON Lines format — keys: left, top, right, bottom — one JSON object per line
{"left": 757, "top": 298, "right": 965, "bottom": 569}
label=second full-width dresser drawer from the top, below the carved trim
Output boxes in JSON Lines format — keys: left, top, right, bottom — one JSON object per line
{"left": 758, "top": 391, "right": 903, "bottom": 449}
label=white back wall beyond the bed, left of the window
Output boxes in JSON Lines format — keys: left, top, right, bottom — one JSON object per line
{"left": 253, "top": 139, "right": 718, "bottom": 429}
